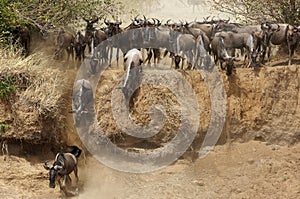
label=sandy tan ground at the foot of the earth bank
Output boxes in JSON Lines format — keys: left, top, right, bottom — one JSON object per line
{"left": 0, "top": 142, "right": 300, "bottom": 199}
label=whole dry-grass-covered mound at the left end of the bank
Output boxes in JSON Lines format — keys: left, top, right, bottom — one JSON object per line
{"left": 0, "top": 47, "right": 69, "bottom": 143}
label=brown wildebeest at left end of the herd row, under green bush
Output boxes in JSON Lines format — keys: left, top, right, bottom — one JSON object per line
{"left": 54, "top": 29, "right": 75, "bottom": 61}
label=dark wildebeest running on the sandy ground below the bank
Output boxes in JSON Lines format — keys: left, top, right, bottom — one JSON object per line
{"left": 44, "top": 146, "right": 81, "bottom": 196}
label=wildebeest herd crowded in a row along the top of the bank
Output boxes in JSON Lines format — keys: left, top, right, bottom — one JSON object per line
{"left": 55, "top": 16, "right": 299, "bottom": 75}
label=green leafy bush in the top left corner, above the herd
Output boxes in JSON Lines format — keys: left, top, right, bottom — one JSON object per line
{"left": 0, "top": 0, "right": 123, "bottom": 44}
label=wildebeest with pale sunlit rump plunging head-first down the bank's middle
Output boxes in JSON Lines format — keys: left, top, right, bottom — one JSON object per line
{"left": 122, "top": 48, "right": 143, "bottom": 100}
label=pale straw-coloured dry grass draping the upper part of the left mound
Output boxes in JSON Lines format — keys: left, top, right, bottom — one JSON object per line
{"left": 0, "top": 48, "right": 66, "bottom": 116}
